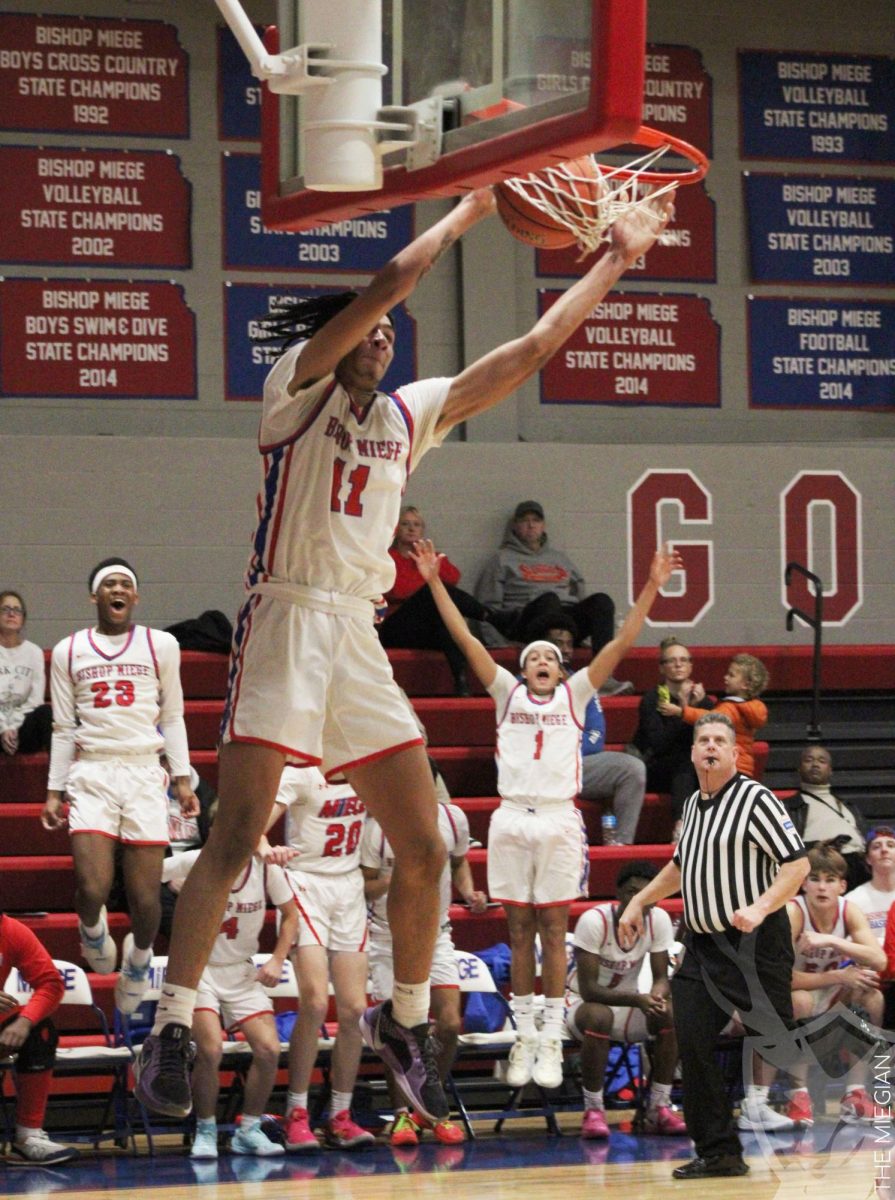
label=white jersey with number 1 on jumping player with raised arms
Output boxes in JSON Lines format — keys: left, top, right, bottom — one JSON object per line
{"left": 488, "top": 667, "right": 594, "bottom": 805}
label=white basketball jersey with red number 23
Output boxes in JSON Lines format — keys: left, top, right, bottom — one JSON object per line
{"left": 54, "top": 625, "right": 167, "bottom": 755}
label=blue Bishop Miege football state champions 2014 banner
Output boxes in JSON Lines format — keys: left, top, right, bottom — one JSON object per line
{"left": 747, "top": 296, "right": 895, "bottom": 412}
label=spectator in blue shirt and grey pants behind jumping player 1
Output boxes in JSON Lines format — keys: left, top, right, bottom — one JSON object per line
{"left": 543, "top": 617, "right": 647, "bottom": 846}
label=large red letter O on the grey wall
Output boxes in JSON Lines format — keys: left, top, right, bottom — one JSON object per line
{"left": 780, "top": 470, "right": 864, "bottom": 625}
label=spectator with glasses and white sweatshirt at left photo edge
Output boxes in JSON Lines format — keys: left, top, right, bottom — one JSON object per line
{"left": 0, "top": 590, "right": 53, "bottom": 755}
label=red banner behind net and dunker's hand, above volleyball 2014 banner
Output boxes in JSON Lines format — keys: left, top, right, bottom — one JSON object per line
{"left": 535, "top": 182, "right": 716, "bottom": 283}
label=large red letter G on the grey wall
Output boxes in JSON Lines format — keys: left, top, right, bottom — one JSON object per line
{"left": 627, "top": 470, "right": 715, "bottom": 625}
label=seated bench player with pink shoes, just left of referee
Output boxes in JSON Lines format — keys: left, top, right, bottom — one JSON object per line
{"left": 565, "top": 862, "right": 686, "bottom": 1138}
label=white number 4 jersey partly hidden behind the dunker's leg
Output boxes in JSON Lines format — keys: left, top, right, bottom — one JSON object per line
{"left": 162, "top": 850, "right": 294, "bottom": 967}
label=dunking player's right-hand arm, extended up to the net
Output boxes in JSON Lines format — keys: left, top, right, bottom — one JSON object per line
{"left": 438, "top": 192, "right": 674, "bottom": 433}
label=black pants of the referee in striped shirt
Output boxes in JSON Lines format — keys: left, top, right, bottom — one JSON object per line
{"left": 672, "top": 908, "right": 793, "bottom": 1158}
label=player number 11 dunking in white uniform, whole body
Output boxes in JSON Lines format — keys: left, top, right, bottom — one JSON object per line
{"left": 137, "top": 188, "right": 672, "bottom": 1121}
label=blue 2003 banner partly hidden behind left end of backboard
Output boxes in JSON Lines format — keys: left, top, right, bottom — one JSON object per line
{"left": 221, "top": 151, "right": 414, "bottom": 274}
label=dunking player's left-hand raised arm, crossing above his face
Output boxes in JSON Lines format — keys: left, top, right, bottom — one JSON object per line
{"left": 289, "top": 187, "right": 495, "bottom": 395}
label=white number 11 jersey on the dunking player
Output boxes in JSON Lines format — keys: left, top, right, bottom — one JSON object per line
{"left": 246, "top": 343, "right": 452, "bottom": 609}
